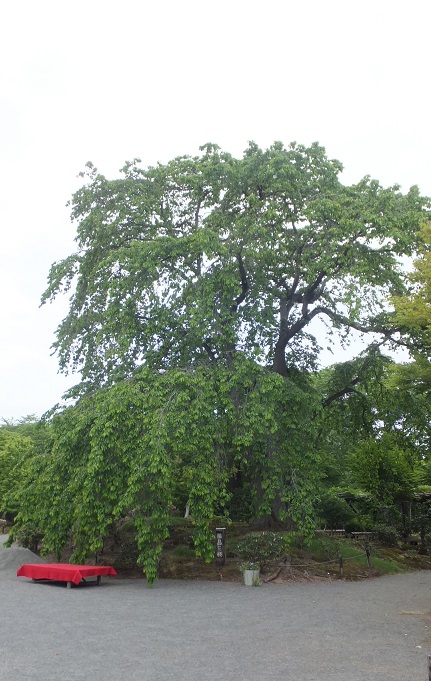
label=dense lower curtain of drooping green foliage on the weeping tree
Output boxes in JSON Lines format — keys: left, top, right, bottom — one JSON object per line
{"left": 11, "top": 356, "right": 316, "bottom": 582}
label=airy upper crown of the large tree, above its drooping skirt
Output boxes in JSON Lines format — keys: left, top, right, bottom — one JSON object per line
{"left": 43, "top": 143, "right": 427, "bottom": 390}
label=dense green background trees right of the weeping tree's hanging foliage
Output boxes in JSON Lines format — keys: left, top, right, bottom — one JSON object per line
{"left": 316, "top": 347, "right": 430, "bottom": 530}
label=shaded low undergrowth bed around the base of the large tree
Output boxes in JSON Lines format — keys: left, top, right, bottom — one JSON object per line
{"left": 89, "top": 518, "right": 431, "bottom": 581}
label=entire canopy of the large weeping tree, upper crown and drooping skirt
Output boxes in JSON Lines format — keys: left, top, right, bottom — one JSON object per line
{"left": 17, "top": 143, "right": 428, "bottom": 580}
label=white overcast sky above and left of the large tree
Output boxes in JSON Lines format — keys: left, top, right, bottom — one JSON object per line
{"left": 0, "top": 0, "right": 431, "bottom": 419}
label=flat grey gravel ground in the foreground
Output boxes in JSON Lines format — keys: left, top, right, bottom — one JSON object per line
{"left": 0, "top": 537, "right": 431, "bottom": 681}
